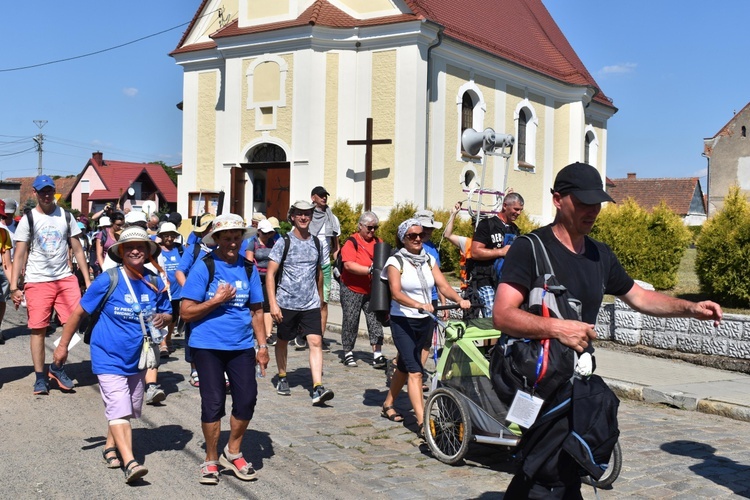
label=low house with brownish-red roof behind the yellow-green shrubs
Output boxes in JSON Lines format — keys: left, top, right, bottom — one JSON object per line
{"left": 607, "top": 173, "right": 706, "bottom": 226}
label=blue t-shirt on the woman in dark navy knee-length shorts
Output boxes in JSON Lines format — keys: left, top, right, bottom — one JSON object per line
{"left": 182, "top": 253, "right": 263, "bottom": 351}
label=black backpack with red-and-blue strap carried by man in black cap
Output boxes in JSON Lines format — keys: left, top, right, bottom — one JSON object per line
{"left": 490, "top": 233, "right": 581, "bottom": 405}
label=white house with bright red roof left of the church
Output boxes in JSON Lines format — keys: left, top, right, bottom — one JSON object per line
{"left": 65, "top": 151, "right": 177, "bottom": 214}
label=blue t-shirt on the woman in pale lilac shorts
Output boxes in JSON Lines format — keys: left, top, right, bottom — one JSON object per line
{"left": 81, "top": 270, "right": 172, "bottom": 376}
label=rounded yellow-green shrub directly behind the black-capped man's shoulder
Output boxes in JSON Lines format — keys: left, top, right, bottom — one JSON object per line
{"left": 591, "top": 199, "right": 691, "bottom": 290}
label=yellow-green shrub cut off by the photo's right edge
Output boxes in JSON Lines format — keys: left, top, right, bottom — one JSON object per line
{"left": 695, "top": 186, "right": 750, "bottom": 307}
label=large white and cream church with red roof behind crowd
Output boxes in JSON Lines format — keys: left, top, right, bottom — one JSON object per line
{"left": 171, "top": 0, "right": 617, "bottom": 221}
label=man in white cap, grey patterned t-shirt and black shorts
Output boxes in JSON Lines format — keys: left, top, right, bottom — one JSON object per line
{"left": 266, "top": 200, "right": 333, "bottom": 405}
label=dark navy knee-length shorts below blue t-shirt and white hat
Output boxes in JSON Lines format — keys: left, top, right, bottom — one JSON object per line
{"left": 193, "top": 348, "right": 258, "bottom": 424}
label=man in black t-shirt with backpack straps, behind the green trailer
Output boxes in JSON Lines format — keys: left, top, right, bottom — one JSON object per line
{"left": 469, "top": 193, "right": 523, "bottom": 317}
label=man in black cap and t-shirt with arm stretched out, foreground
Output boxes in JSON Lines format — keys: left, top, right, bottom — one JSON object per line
{"left": 493, "top": 163, "right": 722, "bottom": 498}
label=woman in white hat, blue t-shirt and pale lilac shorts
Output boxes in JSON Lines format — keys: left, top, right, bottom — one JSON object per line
{"left": 54, "top": 226, "right": 172, "bottom": 483}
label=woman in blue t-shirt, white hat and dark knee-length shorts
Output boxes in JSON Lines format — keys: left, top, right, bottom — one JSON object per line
{"left": 180, "top": 214, "right": 269, "bottom": 484}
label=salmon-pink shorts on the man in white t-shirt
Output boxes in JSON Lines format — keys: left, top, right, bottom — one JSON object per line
{"left": 23, "top": 275, "right": 81, "bottom": 330}
